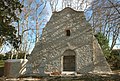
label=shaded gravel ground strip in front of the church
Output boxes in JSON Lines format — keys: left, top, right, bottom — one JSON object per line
{"left": 0, "top": 74, "right": 120, "bottom": 81}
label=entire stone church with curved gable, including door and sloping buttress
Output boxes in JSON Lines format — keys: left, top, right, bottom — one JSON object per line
{"left": 27, "top": 7, "right": 111, "bottom": 75}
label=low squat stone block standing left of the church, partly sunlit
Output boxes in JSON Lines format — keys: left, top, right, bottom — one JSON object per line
{"left": 4, "top": 59, "right": 28, "bottom": 78}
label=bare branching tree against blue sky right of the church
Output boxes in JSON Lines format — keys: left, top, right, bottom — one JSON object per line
{"left": 91, "top": 0, "right": 120, "bottom": 50}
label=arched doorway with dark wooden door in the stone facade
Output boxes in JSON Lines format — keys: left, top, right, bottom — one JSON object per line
{"left": 63, "top": 50, "right": 76, "bottom": 71}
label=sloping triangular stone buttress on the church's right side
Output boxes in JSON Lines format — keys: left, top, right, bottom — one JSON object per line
{"left": 93, "top": 37, "right": 111, "bottom": 73}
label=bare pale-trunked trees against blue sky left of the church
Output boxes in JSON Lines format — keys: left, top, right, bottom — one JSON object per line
{"left": 6, "top": 0, "right": 47, "bottom": 59}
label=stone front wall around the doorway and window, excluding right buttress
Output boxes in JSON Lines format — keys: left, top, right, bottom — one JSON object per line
{"left": 29, "top": 8, "right": 110, "bottom": 73}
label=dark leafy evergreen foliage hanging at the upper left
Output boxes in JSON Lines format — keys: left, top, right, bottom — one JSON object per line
{"left": 0, "top": 0, "right": 23, "bottom": 48}
